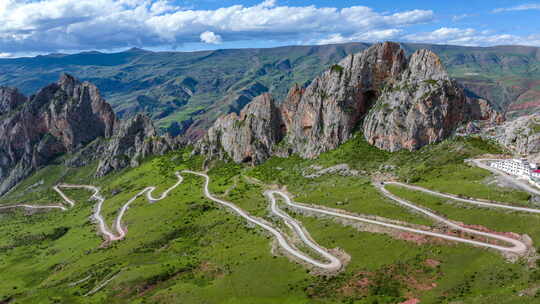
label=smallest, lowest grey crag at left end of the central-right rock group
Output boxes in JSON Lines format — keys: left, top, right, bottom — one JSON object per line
{"left": 197, "top": 94, "right": 283, "bottom": 163}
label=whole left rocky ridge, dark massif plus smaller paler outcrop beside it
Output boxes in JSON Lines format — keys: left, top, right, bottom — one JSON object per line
{"left": 0, "top": 74, "right": 173, "bottom": 195}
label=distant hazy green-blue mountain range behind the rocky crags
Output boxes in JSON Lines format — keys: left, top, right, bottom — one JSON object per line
{"left": 0, "top": 43, "right": 540, "bottom": 137}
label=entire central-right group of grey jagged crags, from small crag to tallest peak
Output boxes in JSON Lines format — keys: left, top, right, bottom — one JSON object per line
{"left": 197, "top": 42, "right": 502, "bottom": 163}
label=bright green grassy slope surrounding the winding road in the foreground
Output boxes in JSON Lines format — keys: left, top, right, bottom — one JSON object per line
{"left": 0, "top": 136, "right": 540, "bottom": 304}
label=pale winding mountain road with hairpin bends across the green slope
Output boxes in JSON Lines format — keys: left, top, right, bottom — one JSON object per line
{"left": 0, "top": 160, "right": 540, "bottom": 272}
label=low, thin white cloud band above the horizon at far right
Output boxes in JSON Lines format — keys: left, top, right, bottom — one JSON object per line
{"left": 403, "top": 27, "right": 540, "bottom": 46}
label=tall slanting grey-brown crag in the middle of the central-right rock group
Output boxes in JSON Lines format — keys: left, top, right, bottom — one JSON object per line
{"left": 283, "top": 42, "right": 406, "bottom": 158}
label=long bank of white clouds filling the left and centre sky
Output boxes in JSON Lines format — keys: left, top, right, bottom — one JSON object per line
{"left": 0, "top": 0, "right": 434, "bottom": 53}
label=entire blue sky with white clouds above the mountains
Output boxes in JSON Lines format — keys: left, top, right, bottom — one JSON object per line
{"left": 0, "top": 0, "right": 540, "bottom": 57}
